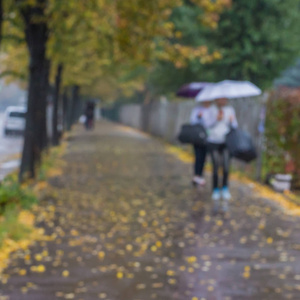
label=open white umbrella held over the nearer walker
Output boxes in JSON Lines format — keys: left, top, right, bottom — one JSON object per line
{"left": 196, "top": 80, "right": 261, "bottom": 102}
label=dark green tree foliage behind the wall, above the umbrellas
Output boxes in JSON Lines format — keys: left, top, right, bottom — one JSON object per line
{"left": 148, "top": 0, "right": 300, "bottom": 95}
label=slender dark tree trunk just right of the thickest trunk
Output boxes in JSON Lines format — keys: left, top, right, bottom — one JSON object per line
{"left": 52, "top": 64, "right": 63, "bottom": 146}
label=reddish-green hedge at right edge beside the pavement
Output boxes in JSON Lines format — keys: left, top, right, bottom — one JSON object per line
{"left": 264, "top": 88, "right": 300, "bottom": 189}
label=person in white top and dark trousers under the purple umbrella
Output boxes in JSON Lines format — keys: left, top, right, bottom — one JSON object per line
{"left": 190, "top": 101, "right": 213, "bottom": 186}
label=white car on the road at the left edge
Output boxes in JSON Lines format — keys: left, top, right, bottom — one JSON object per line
{"left": 3, "top": 106, "right": 26, "bottom": 135}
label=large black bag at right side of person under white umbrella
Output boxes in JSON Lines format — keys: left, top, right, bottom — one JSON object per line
{"left": 226, "top": 129, "right": 257, "bottom": 162}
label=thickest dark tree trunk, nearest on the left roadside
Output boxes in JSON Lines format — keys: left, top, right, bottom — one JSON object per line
{"left": 19, "top": 0, "right": 49, "bottom": 181}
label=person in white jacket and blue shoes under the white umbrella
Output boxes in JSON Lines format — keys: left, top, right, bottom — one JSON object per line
{"left": 207, "top": 98, "right": 238, "bottom": 213}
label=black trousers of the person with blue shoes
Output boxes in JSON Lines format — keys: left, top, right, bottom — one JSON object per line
{"left": 208, "top": 143, "right": 230, "bottom": 189}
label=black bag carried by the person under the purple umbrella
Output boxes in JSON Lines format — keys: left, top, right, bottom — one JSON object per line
{"left": 178, "top": 124, "right": 207, "bottom": 146}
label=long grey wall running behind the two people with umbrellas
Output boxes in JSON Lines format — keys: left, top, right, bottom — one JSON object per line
{"left": 119, "top": 98, "right": 262, "bottom": 143}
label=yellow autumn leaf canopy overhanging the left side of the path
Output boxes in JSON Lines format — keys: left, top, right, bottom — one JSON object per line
{"left": 1, "top": 0, "right": 231, "bottom": 98}
